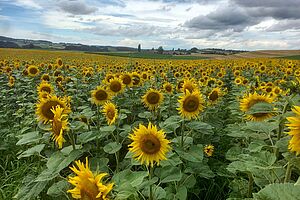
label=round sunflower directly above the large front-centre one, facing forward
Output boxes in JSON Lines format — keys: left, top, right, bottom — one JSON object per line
{"left": 142, "top": 88, "right": 164, "bottom": 110}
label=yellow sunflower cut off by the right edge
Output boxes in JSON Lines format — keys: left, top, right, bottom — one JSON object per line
{"left": 286, "top": 106, "right": 300, "bottom": 155}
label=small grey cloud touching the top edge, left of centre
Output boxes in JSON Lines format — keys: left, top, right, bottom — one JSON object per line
{"left": 58, "top": 0, "right": 98, "bottom": 15}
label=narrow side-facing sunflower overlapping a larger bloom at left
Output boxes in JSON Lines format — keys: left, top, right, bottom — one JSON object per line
{"left": 50, "top": 105, "right": 68, "bottom": 149}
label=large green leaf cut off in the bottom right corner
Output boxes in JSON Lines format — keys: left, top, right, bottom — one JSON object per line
{"left": 253, "top": 183, "right": 300, "bottom": 200}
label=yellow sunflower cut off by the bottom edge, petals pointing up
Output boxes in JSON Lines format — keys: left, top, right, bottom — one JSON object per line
{"left": 68, "top": 158, "right": 114, "bottom": 200}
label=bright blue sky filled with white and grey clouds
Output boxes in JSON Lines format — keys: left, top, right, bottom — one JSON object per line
{"left": 0, "top": 0, "right": 300, "bottom": 50}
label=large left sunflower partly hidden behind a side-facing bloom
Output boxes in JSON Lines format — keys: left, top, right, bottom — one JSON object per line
{"left": 36, "top": 95, "right": 71, "bottom": 123}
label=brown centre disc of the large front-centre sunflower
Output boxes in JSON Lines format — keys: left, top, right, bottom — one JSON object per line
{"left": 141, "top": 134, "right": 161, "bottom": 154}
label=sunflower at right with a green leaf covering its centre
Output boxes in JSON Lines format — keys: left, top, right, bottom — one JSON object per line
{"left": 240, "top": 92, "right": 274, "bottom": 121}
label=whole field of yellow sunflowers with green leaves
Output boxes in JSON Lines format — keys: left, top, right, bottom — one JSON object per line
{"left": 0, "top": 49, "right": 300, "bottom": 200}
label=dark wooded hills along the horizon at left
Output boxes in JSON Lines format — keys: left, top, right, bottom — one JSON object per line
{"left": 0, "top": 36, "right": 137, "bottom": 52}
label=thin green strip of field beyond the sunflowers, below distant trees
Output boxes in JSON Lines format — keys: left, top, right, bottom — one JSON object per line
{"left": 85, "top": 52, "right": 206, "bottom": 60}
